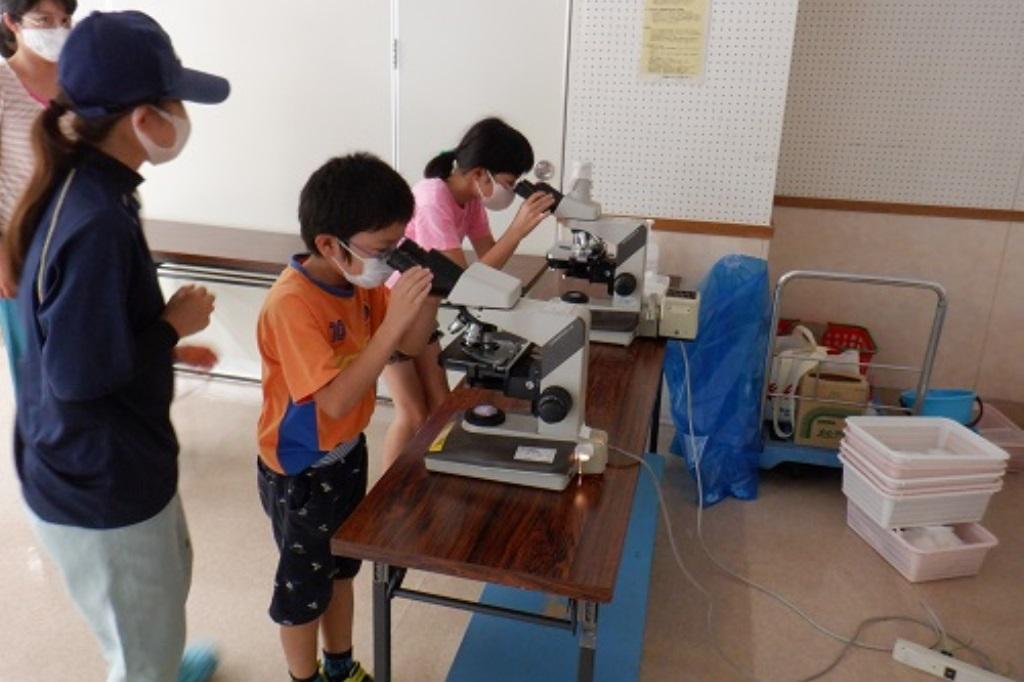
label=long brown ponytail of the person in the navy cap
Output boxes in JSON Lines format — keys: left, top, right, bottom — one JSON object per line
{"left": 3, "top": 93, "right": 127, "bottom": 278}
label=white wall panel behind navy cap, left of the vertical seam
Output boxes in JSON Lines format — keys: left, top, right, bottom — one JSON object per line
{"left": 103, "top": 0, "right": 391, "bottom": 232}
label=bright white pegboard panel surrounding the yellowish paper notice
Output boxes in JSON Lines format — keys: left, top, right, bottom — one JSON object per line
{"left": 565, "top": 0, "right": 797, "bottom": 225}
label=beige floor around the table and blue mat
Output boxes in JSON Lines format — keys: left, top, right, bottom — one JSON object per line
{"left": 0, "top": 371, "right": 1024, "bottom": 682}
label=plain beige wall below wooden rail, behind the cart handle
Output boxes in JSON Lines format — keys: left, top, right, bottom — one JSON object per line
{"left": 769, "top": 207, "right": 1024, "bottom": 400}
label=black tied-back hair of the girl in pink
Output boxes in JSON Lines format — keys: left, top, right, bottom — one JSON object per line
{"left": 423, "top": 118, "right": 534, "bottom": 180}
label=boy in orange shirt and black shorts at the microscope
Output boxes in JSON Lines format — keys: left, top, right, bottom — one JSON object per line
{"left": 257, "top": 154, "right": 438, "bottom": 682}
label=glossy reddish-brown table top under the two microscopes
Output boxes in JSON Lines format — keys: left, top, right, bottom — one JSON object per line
{"left": 333, "top": 339, "right": 665, "bottom": 602}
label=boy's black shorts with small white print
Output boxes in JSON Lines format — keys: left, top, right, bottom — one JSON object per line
{"left": 257, "top": 436, "right": 367, "bottom": 625}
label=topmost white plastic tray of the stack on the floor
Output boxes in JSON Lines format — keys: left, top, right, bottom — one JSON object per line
{"left": 846, "top": 417, "right": 1009, "bottom": 466}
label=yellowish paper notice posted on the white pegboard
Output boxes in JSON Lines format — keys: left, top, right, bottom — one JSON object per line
{"left": 640, "top": 0, "right": 711, "bottom": 78}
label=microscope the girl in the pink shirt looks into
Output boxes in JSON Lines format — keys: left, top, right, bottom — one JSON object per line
{"left": 515, "top": 164, "right": 649, "bottom": 346}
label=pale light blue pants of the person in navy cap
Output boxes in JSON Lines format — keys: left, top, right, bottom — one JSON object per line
{"left": 29, "top": 496, "right": 193, "bottom": 682}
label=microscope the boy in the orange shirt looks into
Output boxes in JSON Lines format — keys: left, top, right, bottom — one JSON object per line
{"left": 388, "top": 240, "right": 608, "bottom": 491}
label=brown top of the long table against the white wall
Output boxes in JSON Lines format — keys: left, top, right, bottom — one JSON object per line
{"left": 144, "top": 220, "right": 546, "bottom": 288}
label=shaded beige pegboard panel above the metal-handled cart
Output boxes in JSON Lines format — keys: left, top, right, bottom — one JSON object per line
{"left": 777, "top": 0, "right": 1024, "bottom": 209}
